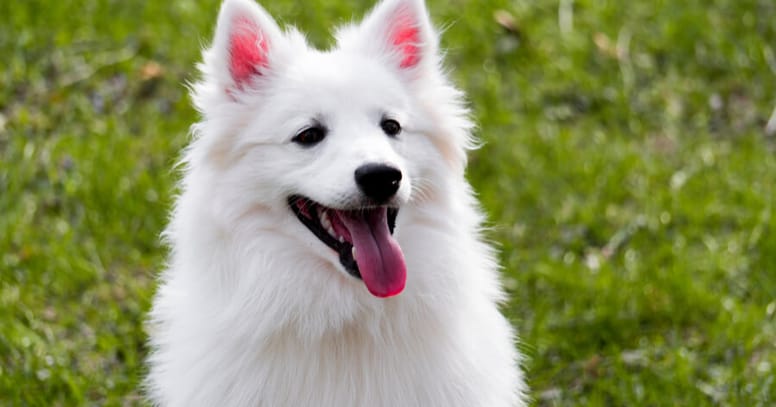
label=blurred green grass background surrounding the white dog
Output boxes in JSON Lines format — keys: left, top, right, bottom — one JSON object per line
{"left": 0, "top": 0, "right": 776, "bottom": 406}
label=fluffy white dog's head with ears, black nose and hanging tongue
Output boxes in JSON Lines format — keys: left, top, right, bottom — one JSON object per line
{"left": 187, "top": 0, "right": 470, "bottom": 297}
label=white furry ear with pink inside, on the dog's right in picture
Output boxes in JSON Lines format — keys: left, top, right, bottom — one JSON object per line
{"left": 339, "top": 0, "right": 438, "bottom": 77}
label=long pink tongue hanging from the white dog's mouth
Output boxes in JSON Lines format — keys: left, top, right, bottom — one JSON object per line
{"left": 338, "top": 207, "right": 407, "bottom": 298}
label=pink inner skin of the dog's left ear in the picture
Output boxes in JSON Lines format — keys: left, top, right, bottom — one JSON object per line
{"left": 229, "top": 18, "right": 269, "bottom": 86}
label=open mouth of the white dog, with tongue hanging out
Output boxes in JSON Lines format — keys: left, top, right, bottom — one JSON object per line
{"left": 288, "top": 195, "right": 407, "bottom": 298}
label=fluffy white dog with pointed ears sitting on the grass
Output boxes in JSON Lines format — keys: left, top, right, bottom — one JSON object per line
{"left": 145, "top": 0, "right": 526, "bottom": 407}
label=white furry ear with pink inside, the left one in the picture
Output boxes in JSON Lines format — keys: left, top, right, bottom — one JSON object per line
{"left": 205, "top": 0, "right": 285, "bottom": 92}
